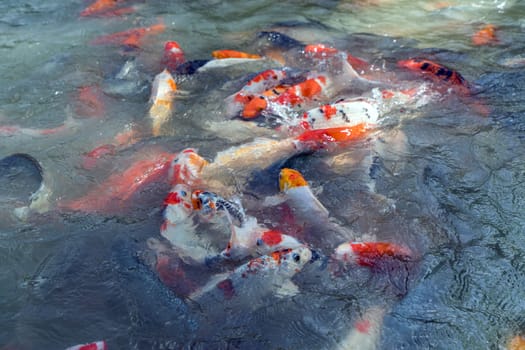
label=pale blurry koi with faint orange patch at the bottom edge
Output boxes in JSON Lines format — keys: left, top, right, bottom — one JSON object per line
{"left": 337, "top": 307, "right": 385, "bottom": 350}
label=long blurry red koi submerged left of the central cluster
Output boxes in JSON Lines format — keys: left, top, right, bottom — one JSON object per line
{"left": 58, "top": 152, "right": 174, "bottom": 212}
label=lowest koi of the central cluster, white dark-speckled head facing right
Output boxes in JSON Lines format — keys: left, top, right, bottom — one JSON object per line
{"left": 189, "top": 247, "right": 312, "bottom": 310}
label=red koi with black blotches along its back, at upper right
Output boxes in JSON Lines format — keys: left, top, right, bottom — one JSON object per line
{"left": 397, "top": 58, "right": 470, "bottom": 96}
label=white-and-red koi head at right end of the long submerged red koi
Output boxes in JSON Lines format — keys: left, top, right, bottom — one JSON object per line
{"left": 169, "top": 148, "right": 208, "bottom": 186}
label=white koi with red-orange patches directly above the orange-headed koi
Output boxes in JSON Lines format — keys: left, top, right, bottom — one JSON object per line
{"left": 225, "top": 69, "right": 287, "bottom": 116}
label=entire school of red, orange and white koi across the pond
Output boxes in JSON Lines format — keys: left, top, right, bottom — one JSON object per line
{"left": 4, "top": 0, "right": 523, "bottom": 350}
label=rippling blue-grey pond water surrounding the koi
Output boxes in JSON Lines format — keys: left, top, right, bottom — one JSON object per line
{"left": 0, "top": 0, "right": 525, "bottom": 349}
